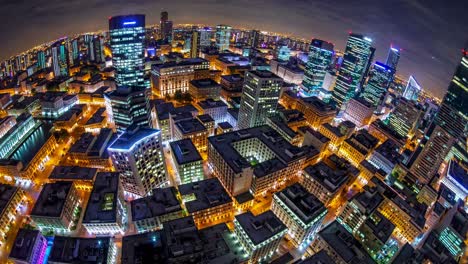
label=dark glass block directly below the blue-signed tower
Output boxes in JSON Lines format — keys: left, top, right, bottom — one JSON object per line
{"left": 104, "top": 86, "right": 151, "bottom": 132}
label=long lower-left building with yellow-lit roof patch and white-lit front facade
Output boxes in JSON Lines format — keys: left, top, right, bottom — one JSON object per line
{"left": 82, "top": 172, "right": 127, "bottom": 235}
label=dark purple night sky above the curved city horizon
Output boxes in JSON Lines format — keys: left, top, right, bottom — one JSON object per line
{"left": 0, "top": 0, "right": 468, "bottom": 97}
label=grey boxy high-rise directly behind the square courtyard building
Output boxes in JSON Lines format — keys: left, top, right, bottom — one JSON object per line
{"left": 238, "top": 71, "right": 283, "bottom": 129}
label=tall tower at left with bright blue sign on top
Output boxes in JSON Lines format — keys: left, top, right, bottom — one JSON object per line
{"left": 109, "top": 15, "right": 146, "bottom": 87}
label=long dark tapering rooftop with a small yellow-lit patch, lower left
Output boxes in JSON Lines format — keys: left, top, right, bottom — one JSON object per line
{"left": 83, "top": 172, "right": 120, "bottom": 224}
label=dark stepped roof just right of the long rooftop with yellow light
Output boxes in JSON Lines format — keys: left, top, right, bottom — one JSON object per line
{"left": 130, "top": 187, "right": 182, "bottom": 221}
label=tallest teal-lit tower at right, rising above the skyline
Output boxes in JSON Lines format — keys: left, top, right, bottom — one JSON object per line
{"left": 331, "top": 33, "right": 375, "bottom": 107}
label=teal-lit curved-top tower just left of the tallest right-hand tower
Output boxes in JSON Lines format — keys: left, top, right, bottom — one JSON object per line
{"left": 302, "top": 39, "right": 333, "bottom": 97}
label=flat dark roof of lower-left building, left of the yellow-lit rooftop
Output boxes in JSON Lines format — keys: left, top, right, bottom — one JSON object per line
{"left": 31, "top": 181, "right": 73, "bottom": 217}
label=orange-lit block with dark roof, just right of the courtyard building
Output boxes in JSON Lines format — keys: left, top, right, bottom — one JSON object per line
{"left": 301, "top": 154, "right": 359, "bottom": 206}
